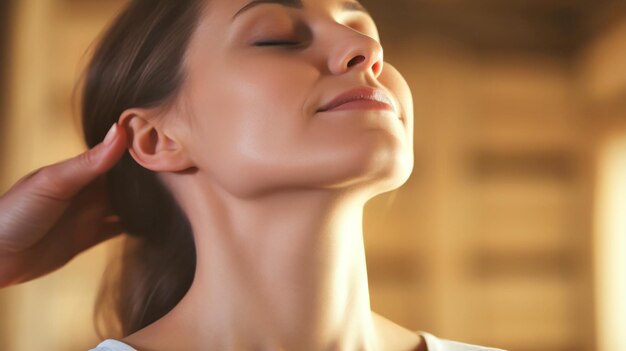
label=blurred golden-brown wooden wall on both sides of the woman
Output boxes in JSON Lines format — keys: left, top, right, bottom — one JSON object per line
{"left": 0, "top": 0, "right": 626, "bottom": 351}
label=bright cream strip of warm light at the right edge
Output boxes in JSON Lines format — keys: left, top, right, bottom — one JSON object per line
{"left": 595, "top": 133, "right": 626, "bottom": 351}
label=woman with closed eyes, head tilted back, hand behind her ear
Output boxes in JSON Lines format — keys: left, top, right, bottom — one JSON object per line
{"left": 0, "top": 0, "right": 500, "bottom": 350}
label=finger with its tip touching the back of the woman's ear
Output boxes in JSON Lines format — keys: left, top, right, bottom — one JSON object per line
{"left": 31, "top": 124, "right": 127, "bottom": 200}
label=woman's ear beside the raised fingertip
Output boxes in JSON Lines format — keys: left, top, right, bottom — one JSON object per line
{"left": 119, "top": 108, "right": 194, "bottom": 172}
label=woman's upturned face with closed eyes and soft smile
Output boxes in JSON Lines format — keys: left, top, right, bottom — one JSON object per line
{"left": 176, "top": 0, "right": 413, "bottom": 197}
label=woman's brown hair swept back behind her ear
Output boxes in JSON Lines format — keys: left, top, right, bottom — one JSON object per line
{"left": 81, "top": 0, "right": 204, "bottom": 337}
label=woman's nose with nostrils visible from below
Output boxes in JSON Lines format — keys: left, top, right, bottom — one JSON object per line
{"left": 329, "top": 27, "right": 383, "bottom": 78}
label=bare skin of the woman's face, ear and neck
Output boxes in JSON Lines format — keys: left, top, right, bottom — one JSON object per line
{"left": 120, "top": 0, "right": 423, "bottom": 351}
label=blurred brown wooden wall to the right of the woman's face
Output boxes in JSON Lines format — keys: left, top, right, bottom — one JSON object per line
{"left": 366, "top": 0, "right": 626, "bottom": 351}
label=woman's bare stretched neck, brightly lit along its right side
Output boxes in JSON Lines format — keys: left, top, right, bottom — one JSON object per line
{"left": 129, "top": 182, "right": 377, "bottom": 350}
